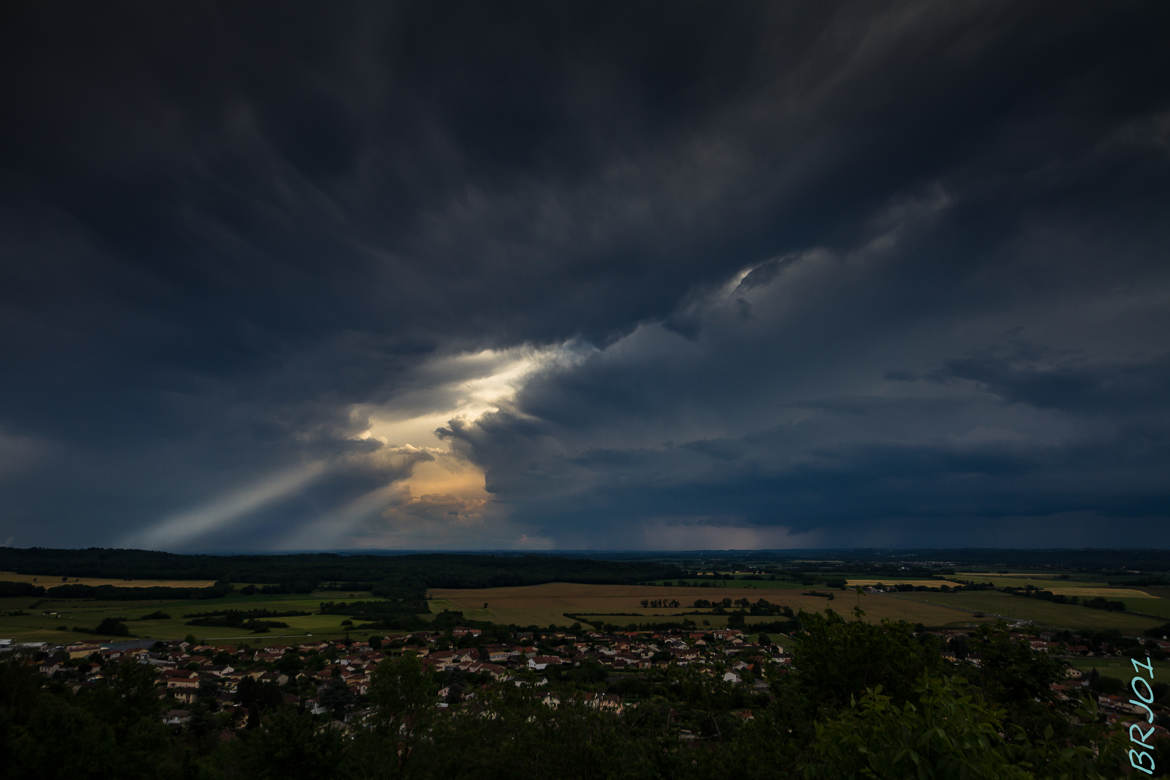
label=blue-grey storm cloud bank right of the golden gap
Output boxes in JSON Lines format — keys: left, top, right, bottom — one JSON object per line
{"left": 447, "top": 171, "right": 1170, "bottom": 546}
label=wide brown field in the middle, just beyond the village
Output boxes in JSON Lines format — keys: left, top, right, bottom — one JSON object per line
{"left": 428, "top": 582, "right": 992, "bottom": 626}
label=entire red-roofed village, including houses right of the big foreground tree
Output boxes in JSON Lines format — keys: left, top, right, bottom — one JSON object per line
{"left": 0, "top": 624, "right": 1170, "bottom": 739}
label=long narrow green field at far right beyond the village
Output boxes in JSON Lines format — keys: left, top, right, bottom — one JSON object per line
{"left": 890, "top": 591, "right": 1159, "bottom": 631}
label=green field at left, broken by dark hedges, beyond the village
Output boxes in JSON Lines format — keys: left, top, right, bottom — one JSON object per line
{"left": 0, "top": 591, "right": 397, "bottom": 644}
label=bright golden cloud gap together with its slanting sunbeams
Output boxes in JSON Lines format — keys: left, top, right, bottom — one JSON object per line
{"left": 123, "top": 347, "right": 577, "bottom": 550}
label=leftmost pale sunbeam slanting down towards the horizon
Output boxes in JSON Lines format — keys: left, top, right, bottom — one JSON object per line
{"left": 123, "top": 461, "right": 328, "bottom": 550}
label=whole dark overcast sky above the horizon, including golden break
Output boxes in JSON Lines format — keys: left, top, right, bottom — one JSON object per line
{"left": 0, "top": 0, "right": 1170, "bottom": 551}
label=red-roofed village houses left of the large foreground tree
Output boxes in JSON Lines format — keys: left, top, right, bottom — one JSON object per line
{"left": 0, "top": 627, "right": 791, "bottom": 727}
